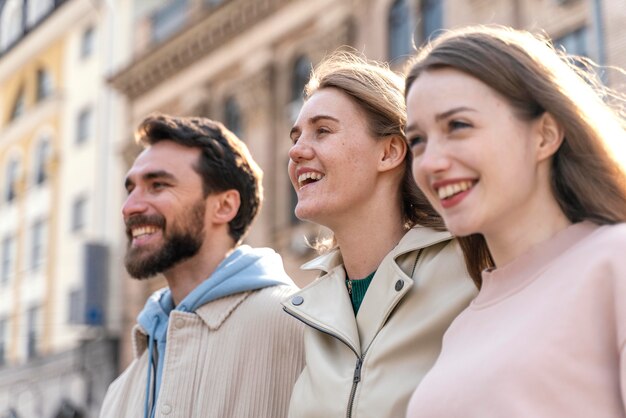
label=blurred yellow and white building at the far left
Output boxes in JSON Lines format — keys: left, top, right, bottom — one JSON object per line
{"left": 0, "top": 0, "right": 129, "bottom": 417}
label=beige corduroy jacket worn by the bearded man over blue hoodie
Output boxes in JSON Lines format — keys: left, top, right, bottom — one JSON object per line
{"left": 100, "top": 285, "right": 304, "bottom": 418}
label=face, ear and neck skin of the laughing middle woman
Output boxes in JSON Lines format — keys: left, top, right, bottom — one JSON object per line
{"left": 289, "top": 88, "right": 407, "bottom": 279}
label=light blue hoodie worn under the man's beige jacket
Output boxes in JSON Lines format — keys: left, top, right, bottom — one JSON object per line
{"left": 137, "top": 245, "right": 295, "bottom": 418}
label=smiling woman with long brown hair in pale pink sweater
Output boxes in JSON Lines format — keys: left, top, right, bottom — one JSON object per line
{"left": 406, "top": 27, "right": 626, "bottom": 418}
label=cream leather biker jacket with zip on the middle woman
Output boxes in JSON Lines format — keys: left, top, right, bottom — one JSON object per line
{"left": 283, "top": 227, "right": 477, "bottom": 418}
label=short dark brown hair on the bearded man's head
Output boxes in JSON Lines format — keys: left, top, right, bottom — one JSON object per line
{"left": 135, "top": 114, "right": 263, "bottom": 243}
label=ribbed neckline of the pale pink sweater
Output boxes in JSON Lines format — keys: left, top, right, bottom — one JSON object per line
{"left": 470, "top": 221, "right": 598, "bottom": 309}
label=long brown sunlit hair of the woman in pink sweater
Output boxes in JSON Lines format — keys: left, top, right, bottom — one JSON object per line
{"left": 405, "top": 26, "right": 626, "bottom": 286}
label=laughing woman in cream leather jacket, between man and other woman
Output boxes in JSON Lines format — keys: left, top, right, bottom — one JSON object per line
{"left": 283, "top": 52, "right": 476, "bottom": 418}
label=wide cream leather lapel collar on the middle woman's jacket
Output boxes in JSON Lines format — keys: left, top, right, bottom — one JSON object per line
{"left": 283, "top": 227, "right": 452, "bottom": 356}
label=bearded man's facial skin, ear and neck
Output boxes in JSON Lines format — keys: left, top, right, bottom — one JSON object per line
{"left": 122, "top": 141, "right": 240, "bottom": 304}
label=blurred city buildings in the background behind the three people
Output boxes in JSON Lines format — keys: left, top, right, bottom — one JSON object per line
{"left": 0, "top": 0, "right": 626, "bottom": 418}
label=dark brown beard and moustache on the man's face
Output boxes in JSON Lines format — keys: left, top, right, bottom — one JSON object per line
{"left": 124, "top": 200, "right": 206, "bottom": 279}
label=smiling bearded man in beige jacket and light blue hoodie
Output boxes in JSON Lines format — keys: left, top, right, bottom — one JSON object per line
{"left": 100, "top": 115, "right": 303, "bottom": 418}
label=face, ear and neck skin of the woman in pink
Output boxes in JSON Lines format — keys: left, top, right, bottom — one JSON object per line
{"left": 407, "top": 68, "right": 570, "bottom": 266}
